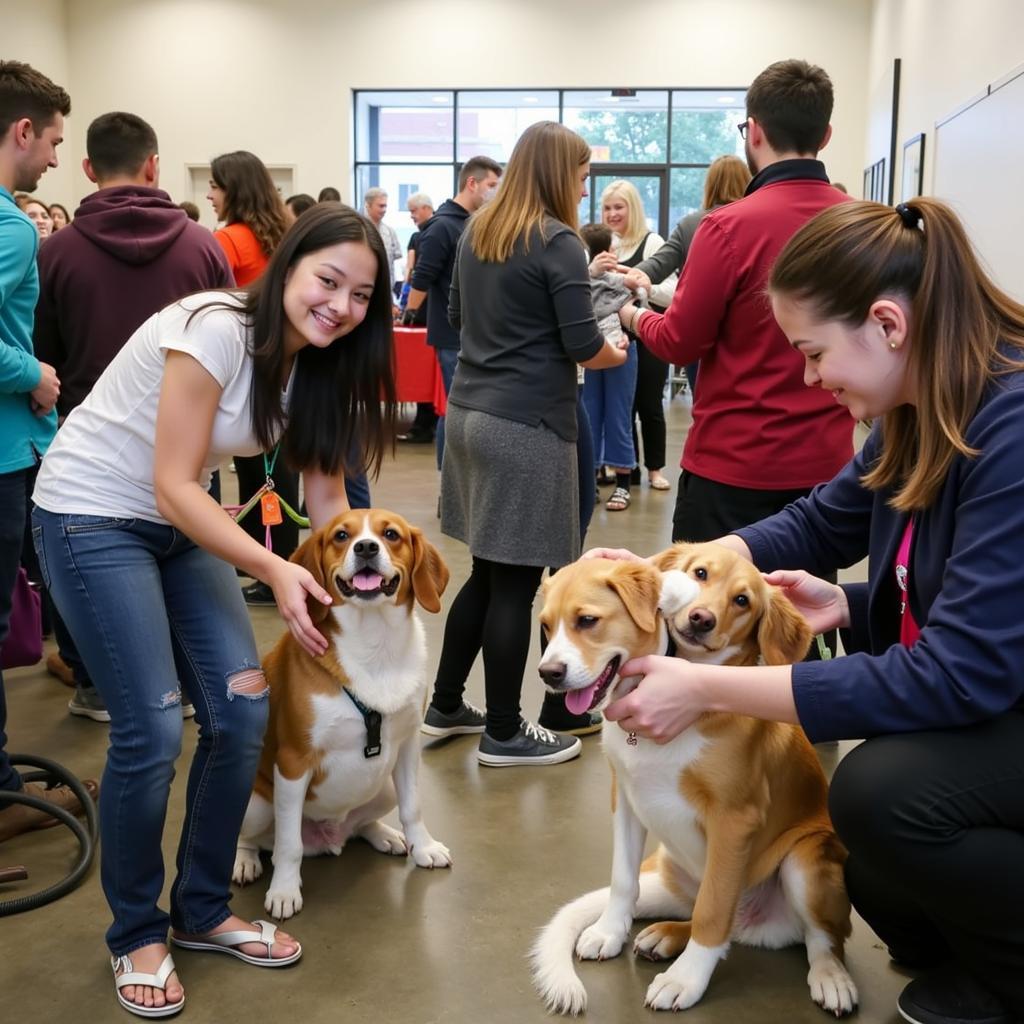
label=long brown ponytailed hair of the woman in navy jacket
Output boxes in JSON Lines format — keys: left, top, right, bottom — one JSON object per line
{"left": 768, "top": 199, "right": 1024, "bottom": 512}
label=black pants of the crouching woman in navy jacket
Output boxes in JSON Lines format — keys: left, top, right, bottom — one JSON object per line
{"left": 829, "top": 712, "right": 1024, "bottom": 1017}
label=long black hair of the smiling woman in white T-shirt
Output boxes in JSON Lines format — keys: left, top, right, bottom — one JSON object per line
{"left": 188, "top": 203, "right": 396, "bottom": 483}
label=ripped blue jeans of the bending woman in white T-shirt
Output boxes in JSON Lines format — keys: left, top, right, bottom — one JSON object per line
{"left": 32, "top": 508, "right": 268, "bottom": 956}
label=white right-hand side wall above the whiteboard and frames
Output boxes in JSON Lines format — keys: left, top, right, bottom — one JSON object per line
{"left": 864, "top": 0, "right": 1024, "bottom": 195}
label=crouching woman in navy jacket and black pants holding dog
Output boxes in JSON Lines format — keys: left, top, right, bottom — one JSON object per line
{"left": 607, "top": 199, "right": 1024, "bottom": 1024}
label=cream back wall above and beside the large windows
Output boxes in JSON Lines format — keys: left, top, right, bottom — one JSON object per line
{"left": 6, "top": 0, "right": 871, "bottom": 211}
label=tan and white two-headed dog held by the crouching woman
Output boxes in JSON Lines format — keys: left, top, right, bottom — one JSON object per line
{"left": 530, "top": 544, "right": 857, "bottom": 1016}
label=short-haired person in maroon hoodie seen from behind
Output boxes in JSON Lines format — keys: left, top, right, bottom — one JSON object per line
{"left": 33, "top": 112, "right": 234, "bottom": 722}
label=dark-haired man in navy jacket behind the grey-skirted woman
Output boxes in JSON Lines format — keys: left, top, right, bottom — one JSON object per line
{"left": 402, "top": 157, "right": 502, "bottom": 469}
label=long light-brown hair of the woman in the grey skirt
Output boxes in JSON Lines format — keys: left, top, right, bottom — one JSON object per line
{"left": 466, "top": 121, "right": 590, "bottom": 263}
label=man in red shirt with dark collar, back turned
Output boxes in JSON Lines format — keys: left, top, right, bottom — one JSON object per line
{"left": 621, "top": 60, "right": 854, "bottom": 541}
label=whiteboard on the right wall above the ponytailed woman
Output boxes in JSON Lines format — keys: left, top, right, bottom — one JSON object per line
{"left": 932, "top": 67, "right": 1024, "bottom": 302}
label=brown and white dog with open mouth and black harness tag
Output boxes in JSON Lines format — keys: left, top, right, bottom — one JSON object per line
{"left": 232, "top": 509, "right": 452, "bottom": 919}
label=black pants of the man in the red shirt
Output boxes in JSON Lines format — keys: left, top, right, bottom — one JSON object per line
{"left": 672, "top": 469, "right": 838, "bottom": 662}
